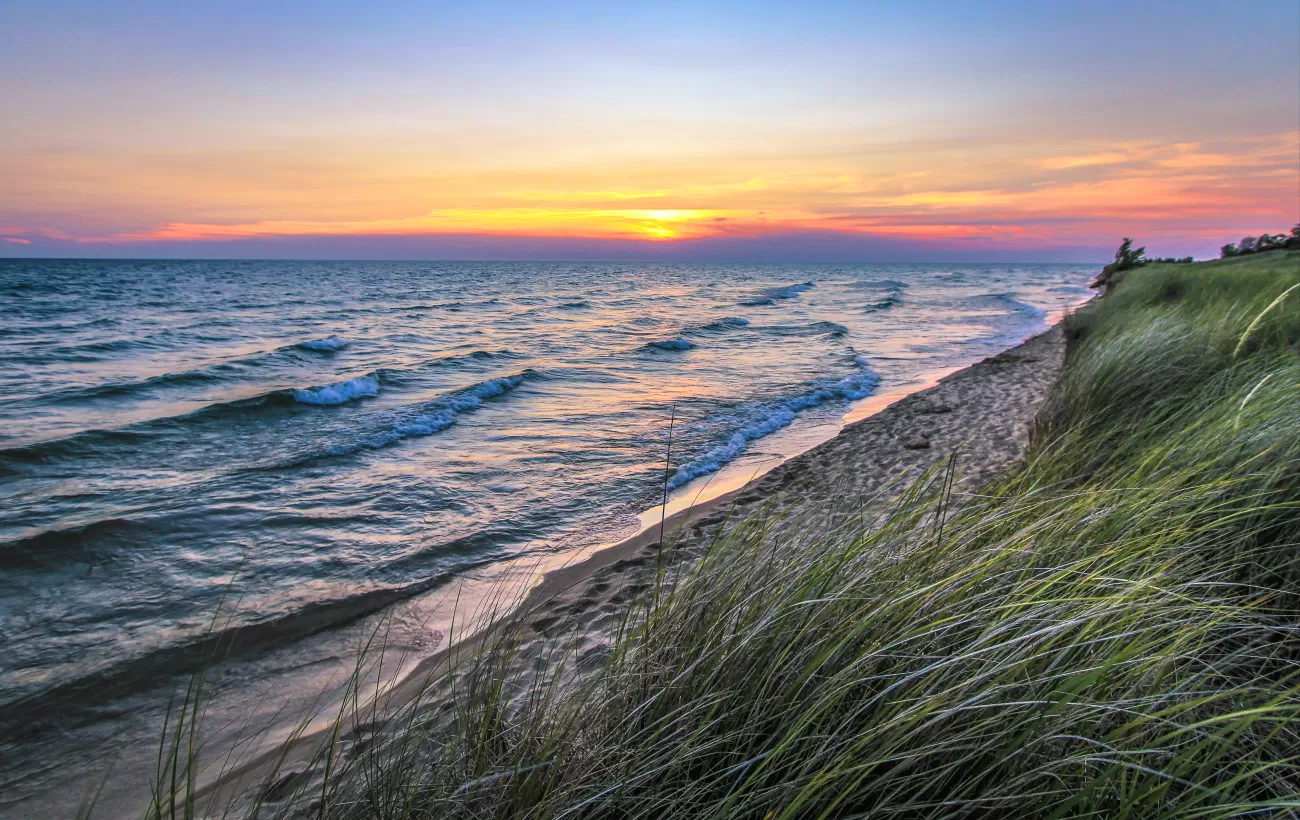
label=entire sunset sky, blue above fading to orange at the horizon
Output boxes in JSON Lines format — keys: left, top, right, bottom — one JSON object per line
{"left": 0, "top": 0, "right": 1300, "bottom": 261}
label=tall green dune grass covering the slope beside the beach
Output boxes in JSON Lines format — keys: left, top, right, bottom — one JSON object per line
{"left": 172, "top": 252, "right": 1300, "bottom": 820}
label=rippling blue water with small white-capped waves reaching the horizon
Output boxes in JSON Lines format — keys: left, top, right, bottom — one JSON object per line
{"left": 0, "top": 260, "right": 1093, "bottom": 816}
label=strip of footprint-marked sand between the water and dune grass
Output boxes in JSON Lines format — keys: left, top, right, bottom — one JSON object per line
{"left": 199, "top": 324, "right": 1066, "bottom": 814}
